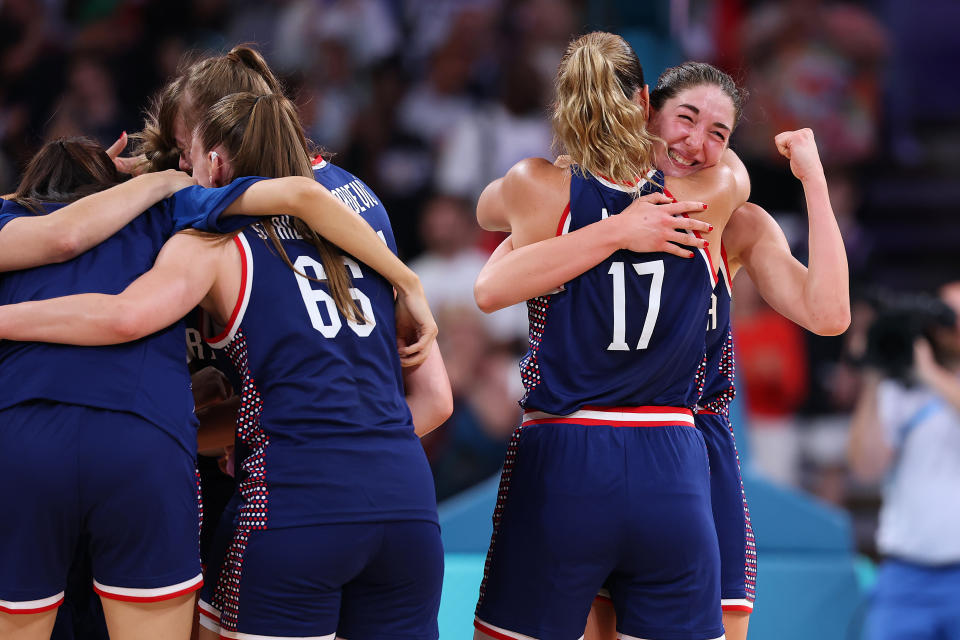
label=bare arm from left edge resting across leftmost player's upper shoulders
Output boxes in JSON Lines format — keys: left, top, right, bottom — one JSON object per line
{"left": 0, "top": 170, "right": 195, "bottom": 271}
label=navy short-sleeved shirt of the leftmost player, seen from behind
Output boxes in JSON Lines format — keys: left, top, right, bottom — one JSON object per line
{"left": 0, "top": 187, "right": 260, "bottom": 452}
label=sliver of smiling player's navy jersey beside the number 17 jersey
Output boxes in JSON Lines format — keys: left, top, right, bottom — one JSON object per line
{"left": 698, "top": 245, "right": 736, "bottom": 416}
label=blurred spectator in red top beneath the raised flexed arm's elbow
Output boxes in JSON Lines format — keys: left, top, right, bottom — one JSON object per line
{"left": 733, "top": 274, "right": 807, "bottom": 486}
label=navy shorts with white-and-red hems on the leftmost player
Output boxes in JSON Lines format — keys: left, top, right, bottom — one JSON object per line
{"left": 0, "top": 402, "right": 202, "bottom": 613}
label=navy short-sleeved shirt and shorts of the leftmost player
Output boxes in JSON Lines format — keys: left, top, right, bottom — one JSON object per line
{"left": 0, "top": 187, "right": 251, "bottom": 613}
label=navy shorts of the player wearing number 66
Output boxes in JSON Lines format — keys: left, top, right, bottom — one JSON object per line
{"left": 200, "top": 521, "right": 443, "bottom": 640}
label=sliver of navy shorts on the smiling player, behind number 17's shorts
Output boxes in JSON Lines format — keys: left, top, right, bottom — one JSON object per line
{"left": 696, "top": 411, "right": 757, "bottom": 613}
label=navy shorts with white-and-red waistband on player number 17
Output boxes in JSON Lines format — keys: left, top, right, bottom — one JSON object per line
{"left": 475, "top": 408, "right": 723, "bottom": 640}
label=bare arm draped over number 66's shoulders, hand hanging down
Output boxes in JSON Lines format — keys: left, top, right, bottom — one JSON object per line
{"left": 224, "top": 177, "right": 437, "bottom": 366}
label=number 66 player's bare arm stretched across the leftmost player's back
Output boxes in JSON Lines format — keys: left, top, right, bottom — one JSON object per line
{"left": 0, "top": 233, "right": 223, "bottom": 346}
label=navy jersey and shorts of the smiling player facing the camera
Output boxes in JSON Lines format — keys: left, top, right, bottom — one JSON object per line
{"left": 695, "top": 247, "right": 757, "bottom": 612}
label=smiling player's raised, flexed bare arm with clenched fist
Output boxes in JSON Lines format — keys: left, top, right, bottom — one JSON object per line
{"left": 723, "top": 129, "right": 850, "bottom": 335}
